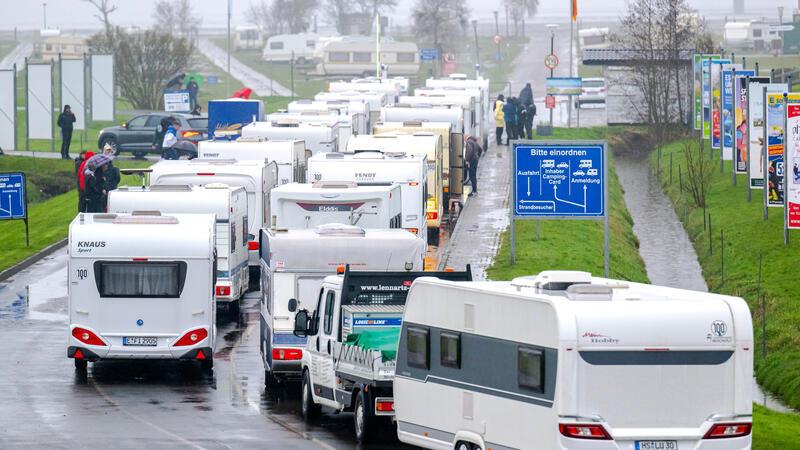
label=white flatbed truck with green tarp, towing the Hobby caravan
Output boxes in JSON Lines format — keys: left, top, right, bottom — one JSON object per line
{"left": 289, "top": 266, "right": 472, "bottom": 442}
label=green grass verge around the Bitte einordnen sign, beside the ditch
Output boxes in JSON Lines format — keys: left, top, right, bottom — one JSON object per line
{"left": 487, "top": 128, "right": 647, "bottom": 282}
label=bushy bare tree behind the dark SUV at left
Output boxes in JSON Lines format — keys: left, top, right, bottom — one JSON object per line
{"left": 88, "top": 27, "right": 194, "bottom": 110}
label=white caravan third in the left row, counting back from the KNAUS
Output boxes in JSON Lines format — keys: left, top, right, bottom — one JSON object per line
{"left": 150, "top": 159, "right": 278, "bottom": 270}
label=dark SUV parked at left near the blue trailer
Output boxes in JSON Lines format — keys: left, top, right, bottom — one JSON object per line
{"left": 97, "top": 113, "right": 208, "bottom": 158}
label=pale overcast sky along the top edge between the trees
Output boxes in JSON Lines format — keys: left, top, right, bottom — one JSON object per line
{"left": 0, "top": 0, "right": 797, "bottom": 29}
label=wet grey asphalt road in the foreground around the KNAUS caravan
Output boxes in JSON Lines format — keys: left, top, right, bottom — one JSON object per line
{"left": 0, "top": 249, "right": 404, "bottom": 449}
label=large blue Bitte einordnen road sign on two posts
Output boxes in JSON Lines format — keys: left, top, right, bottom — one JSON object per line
{"left": 509, "top": 140, "right": 609, "bottom": 277}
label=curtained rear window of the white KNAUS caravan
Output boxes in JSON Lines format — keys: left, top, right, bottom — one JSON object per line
{"left": 94, "top": 261, "right": 186, "bottom": 298}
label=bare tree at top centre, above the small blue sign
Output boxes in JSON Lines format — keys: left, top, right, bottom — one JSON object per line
{"left": 411, "top": 0, "right": 470, "bottom": 55}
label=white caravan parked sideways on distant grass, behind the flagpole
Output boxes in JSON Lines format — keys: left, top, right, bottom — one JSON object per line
{"left": 317, "top": 37, "right": 419, "bottom": 77}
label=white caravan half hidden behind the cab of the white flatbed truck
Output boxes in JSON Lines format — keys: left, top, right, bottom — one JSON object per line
{"left": 259, "top": 224, "right": 425, "bottom": 385}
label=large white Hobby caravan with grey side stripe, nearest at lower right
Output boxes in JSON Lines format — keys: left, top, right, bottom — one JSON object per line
{"left": 394, "top": 271, "right": 754, "bottom": 450}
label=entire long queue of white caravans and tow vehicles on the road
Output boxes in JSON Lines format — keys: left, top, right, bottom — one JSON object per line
{"left": 66, "top": 72, "right": 753, "bottom": 450}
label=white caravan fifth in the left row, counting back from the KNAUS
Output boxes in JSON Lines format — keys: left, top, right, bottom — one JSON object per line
{"left": 242, "top": 120, "right": 339, "bottom": 155}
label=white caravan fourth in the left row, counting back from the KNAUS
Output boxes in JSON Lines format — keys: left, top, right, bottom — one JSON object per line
{"left": 197, "top": 137, "right": 308, "bottom": 185}
